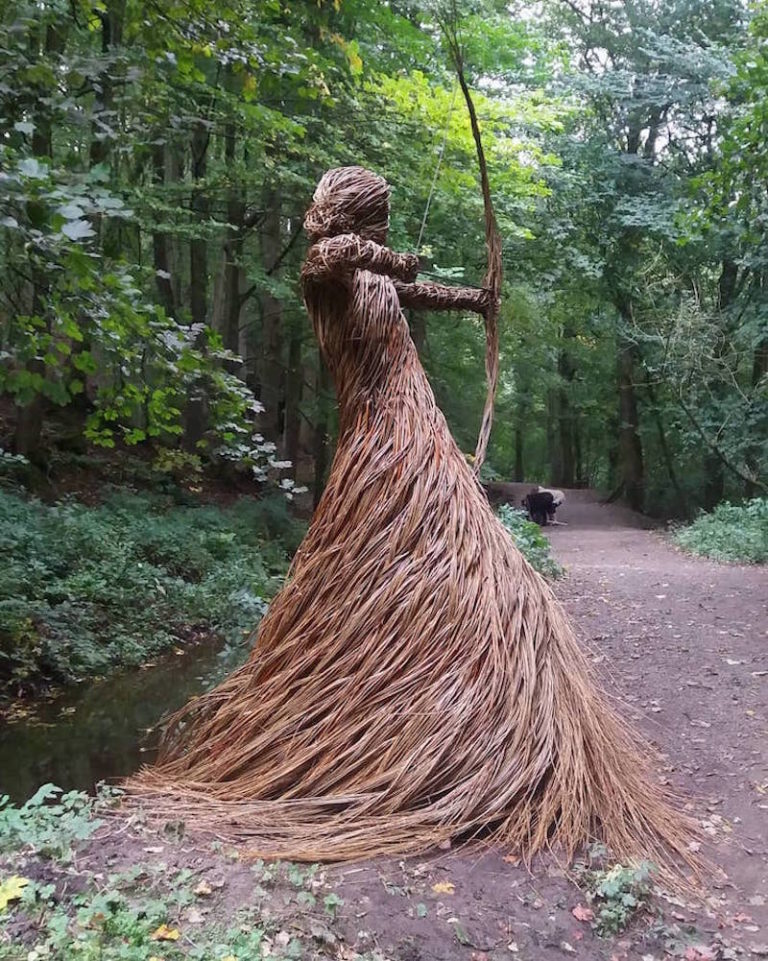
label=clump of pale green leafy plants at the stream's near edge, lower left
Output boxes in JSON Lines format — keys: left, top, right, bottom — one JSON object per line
{"left": 0, "top": 784, "right": 101, "bottom": 863}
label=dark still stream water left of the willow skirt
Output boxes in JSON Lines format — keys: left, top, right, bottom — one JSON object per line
{"left": 0, "top": 641, "right": 244, "bottom": 802}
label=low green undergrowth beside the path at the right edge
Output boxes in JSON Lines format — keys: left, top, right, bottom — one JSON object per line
{"left": 674, "top": 497, "right": 768, "bottom": 564}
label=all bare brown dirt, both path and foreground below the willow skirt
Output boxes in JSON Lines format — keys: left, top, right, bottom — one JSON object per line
{"left": 13, "top": 492, "right": 768, "bottom": 961}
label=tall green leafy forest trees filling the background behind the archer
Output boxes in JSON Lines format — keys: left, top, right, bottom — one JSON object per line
{"left": 0, "top": 0, "right": 768, "bottom": 515}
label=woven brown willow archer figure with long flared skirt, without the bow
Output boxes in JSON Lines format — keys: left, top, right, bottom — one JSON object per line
{"left": 129, "top": 167, "right": 688, "bottom": 863}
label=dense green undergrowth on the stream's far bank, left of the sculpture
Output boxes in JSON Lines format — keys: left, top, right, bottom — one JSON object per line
{"left": 0, "top": 491, "right": 301, "bottom": 689}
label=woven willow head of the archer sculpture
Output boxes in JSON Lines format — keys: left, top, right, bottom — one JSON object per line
{"left": 304, "top": 167, "right": 389, "bottom": 244}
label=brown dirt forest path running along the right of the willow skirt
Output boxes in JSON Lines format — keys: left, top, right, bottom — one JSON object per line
{"left": 547, "top": 502, "right": 768, "bottom": 945}
